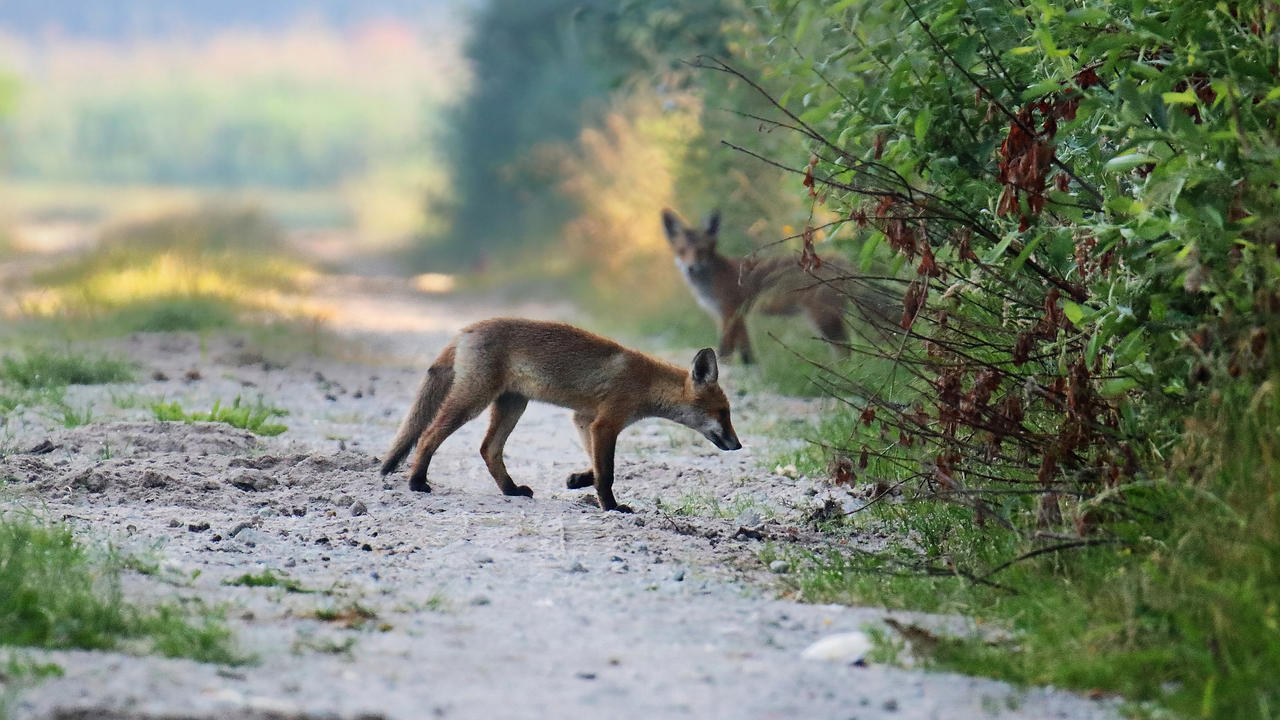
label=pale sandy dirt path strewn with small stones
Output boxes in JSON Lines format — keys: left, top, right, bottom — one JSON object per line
{"left": 0, "top": 275, "right": 1114, "bottom": 720}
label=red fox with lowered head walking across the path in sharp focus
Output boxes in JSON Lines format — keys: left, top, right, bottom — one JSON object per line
{"left": 381, "top": 318, "right": 742, "bottom": 512}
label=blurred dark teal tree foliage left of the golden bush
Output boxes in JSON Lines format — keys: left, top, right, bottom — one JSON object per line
{"left": 434, "top": 0, "right": 732, "bottom": 263}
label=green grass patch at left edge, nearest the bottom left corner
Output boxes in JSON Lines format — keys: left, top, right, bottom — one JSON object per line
{"left": 0, "top": 511, "right": 243, "bottom": 662}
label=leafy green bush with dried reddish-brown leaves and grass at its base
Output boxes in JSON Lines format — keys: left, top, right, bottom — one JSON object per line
{"left": 732, "top": 0, "right": 1280, "bottom": 717}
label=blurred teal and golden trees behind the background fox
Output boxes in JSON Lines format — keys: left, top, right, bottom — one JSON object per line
{"left": 430, "top": 0, "right": 795, "bottom": 296}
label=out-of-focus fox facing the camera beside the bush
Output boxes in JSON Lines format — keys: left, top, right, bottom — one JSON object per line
{"left": 662, "top": 210, "right": 849, "bottom": 363}
